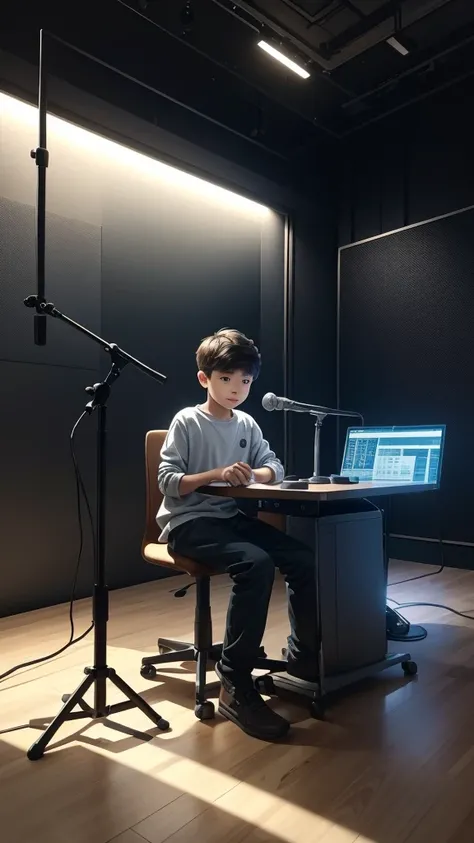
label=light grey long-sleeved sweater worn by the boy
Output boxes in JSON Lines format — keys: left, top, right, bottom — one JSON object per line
{"left": 156, "top": 407, "right": 284, "bottom": 542}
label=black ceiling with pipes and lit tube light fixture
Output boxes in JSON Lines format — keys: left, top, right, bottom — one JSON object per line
{"left": 134, "top": 0, "right": 474, "bottom": 135}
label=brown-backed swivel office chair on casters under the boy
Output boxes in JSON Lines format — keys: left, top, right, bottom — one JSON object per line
{"left": 140, "top": 430, "right": 286, "bottom": 720}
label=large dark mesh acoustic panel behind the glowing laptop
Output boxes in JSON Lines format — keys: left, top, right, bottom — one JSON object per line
{"left": 340, "top": 209, "right": 474, "bottom": 542}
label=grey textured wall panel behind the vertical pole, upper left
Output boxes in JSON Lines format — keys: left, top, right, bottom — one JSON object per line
{"left": 0, "top": 197, "right": 101, "bottom": 369}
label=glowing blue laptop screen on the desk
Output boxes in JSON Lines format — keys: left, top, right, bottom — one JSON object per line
{"left": 341, "top": 424, "right": 446, "bottom": 486}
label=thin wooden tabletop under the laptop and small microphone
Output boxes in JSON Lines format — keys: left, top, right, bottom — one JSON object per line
{"left": 200, "top": 481, "right": 438, "bottom": 501}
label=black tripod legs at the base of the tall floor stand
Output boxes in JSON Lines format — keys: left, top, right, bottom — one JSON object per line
{"left": 27, "top": 667, "right": 169, "bottom": 761}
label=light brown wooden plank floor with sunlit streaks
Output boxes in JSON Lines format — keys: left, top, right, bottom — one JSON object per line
{"left": 0, "top": 564, "right": 474, "bottom": 843}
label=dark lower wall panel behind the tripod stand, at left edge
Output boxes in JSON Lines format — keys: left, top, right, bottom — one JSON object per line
{"left": 0, "top": 362, "right": 97, "bottom": 622}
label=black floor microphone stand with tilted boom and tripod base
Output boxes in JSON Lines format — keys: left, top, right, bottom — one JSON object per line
{"left": 24, "top": 296, "right": 169, "bottom": 761}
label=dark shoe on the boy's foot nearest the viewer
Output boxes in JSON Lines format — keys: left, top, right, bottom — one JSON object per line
{"left": 215, "top": 664, "right": 290, "bottom": 741}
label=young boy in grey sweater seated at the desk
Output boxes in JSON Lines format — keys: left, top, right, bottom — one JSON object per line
{"left": 157, "top": 329, "right": 317, "bottom": 740}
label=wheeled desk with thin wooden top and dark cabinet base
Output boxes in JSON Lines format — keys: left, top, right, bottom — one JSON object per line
{"left": 200, "top": 482, "right": 438, "bottom": 716}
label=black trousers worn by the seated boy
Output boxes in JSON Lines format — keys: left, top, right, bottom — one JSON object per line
{"left": 168, "top": 514, "right": 317, "bottom": 682}
